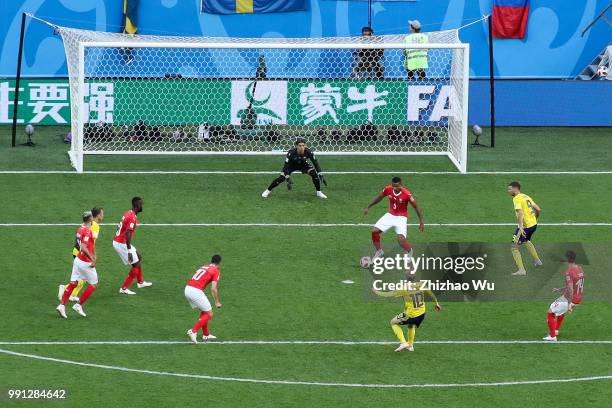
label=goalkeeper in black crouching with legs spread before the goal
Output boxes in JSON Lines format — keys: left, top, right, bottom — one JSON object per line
{"left": 261, "top": 137, "right": 327, "bottom": 198}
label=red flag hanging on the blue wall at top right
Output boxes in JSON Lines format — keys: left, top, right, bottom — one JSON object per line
{"left": 493, "top": 0, "right": 529, "bottom": 38}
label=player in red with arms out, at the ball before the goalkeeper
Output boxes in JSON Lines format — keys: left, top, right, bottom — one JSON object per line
{"left": 363, "top": 177, "right": 425, "bottom": 258}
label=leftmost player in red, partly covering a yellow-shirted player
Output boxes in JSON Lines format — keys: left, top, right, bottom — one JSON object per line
{"left": 56, "top": 211, "right": 98, "bottom": 319}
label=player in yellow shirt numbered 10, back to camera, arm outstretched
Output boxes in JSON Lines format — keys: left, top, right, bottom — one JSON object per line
{"left": 374, "top": 280, "right": 442, "bottom": 352}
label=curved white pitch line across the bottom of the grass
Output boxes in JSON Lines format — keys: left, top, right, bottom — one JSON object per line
{"left": 0, "top": 349, "right": 612, "bottom": 389}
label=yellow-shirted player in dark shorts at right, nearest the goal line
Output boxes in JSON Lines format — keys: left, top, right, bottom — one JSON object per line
{"left": 508, "top": 181, "right": 542, "bottom": 276}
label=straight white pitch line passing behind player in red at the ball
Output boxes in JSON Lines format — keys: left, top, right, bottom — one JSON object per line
{"left": 0, "top": 222, "right": 612, "bottom": 228}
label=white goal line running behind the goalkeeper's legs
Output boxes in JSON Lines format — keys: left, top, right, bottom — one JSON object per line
{"left": 0, "top": 170, "right": 612, "bottom": 176}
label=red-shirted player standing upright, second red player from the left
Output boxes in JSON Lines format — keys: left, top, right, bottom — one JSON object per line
{"left": 113, "top": 197, "right": 152, "bottom": 295}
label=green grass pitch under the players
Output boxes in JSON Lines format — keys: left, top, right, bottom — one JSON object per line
{"left": 0, "top": 127, "right": 612, "bottom": 408}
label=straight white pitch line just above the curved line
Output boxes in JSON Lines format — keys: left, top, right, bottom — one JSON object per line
{"left": 0, "top": 340, "right": 612, "bottom": 346}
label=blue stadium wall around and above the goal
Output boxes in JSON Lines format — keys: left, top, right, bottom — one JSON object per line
{"left": 0, "top": 0, "right": 612, "bottom": 126}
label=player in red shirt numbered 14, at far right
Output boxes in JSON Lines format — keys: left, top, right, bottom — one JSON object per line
{"left": 543, "top": 251, "right": 584, "bottom": 341}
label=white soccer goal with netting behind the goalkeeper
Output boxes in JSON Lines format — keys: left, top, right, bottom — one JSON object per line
{"left": 56, "top": 27, "right": 469, "bottom": 172}
